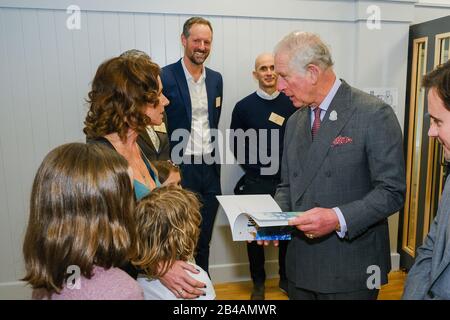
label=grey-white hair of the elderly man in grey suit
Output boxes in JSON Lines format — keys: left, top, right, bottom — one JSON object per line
{"left": 275, "top": 31, "right": 333, "bottom": 74}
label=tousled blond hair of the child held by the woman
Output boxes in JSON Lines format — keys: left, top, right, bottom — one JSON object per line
{"left": 133, "top": 186, "right": 201, "bottom": 278}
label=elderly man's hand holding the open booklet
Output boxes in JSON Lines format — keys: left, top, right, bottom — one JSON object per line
{"left": 289, "top": 208, "right": 339, "bottom": 239}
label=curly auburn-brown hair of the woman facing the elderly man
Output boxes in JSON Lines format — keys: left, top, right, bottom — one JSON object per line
{"left": 83, "top": 57, "right": 160, "bottom": 142}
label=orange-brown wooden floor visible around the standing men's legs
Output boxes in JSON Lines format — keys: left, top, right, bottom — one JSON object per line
{"left": 214, "top": 271, "right": 406, "bottom": 300}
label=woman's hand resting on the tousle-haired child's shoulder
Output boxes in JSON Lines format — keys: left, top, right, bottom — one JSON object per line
{"left": 159, "top": 260, "right": 206, "bottom": 299}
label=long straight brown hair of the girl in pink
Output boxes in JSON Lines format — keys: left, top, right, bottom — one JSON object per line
{"left": 23, "top": 143, "right": 137, "bottom": 293}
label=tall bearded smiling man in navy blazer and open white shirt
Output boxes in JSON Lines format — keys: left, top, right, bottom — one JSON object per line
{"left": 161, "top": 17, "right": 223, "bottom": 271}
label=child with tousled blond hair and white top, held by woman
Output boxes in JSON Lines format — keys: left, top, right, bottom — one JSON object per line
{"left": 133, "top": 186, "right": 216, "bottom": 300}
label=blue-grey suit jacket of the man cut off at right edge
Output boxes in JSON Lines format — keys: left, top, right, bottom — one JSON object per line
{"left": 403, "top": 179, "right": 450, "bottom": 300}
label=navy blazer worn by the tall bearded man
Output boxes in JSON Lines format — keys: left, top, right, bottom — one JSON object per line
{"left": 161, "top": 59, "right": 223, "bottom": 160}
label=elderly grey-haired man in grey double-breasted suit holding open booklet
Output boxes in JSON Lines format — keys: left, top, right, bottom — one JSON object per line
{"left": 275, "top": 32, "right": 406, "bottom": 300}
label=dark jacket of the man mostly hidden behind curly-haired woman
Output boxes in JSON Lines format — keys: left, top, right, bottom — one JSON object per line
{"left": 137, "top": 114, "right": 170, "bottom": 161}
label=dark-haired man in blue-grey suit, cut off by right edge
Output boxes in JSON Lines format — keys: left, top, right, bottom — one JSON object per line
{"left": 403, "top": 61, "right": 450, "bottom": 300}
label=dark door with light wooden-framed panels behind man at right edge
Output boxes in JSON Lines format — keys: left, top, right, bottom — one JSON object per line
{"left": 398, "top": 16, "right": 450, "bottom": 270}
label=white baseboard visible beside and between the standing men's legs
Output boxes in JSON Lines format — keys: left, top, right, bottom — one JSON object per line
{"left": 209, "top": 252, "right": 400, "bottom": 284}
